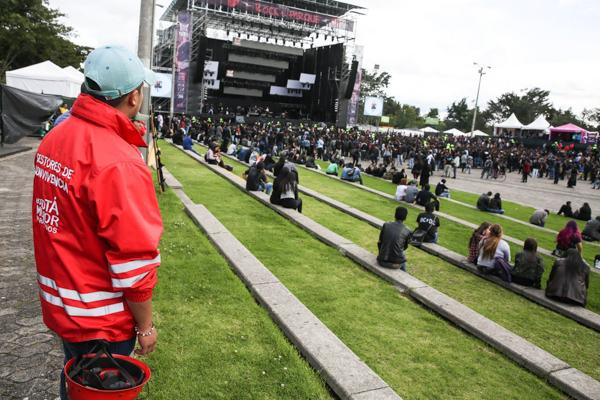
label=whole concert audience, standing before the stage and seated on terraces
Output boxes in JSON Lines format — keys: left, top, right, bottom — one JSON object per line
{"left": 165, "top": 114, "right": 600, "bottom": 305}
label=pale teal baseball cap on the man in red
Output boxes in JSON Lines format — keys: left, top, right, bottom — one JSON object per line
{"left": 83, "top": 45, "right": 155, "bottom": 100}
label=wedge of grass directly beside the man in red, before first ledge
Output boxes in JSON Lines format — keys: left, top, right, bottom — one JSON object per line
{"left": 144, "top": 186, "right": 332, "bottom": 400}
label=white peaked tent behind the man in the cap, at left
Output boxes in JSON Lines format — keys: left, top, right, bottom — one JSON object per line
{"left": 6, "top": 61, "right": 83, "bottom": 97}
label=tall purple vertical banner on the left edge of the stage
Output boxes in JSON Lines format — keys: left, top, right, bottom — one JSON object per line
{"left": 173, "top": 11, "right": 192, "bottom": 113}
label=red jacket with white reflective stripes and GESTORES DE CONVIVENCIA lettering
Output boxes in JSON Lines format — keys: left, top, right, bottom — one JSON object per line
{"left": 32, "top": 94, "right": 162, "bottom": 342}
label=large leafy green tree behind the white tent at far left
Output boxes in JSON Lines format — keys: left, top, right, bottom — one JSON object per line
{"left": 0, "top": 0, "right": 90, "bottom": 80}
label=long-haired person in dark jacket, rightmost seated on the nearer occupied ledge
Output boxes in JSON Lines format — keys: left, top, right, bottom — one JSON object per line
{"left": 546, "top": 249, "right": 590, "bottom": 307}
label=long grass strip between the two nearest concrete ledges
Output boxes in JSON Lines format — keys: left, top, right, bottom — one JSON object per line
{"left": 162, "top": 145, "right": 564, "bottom": 399}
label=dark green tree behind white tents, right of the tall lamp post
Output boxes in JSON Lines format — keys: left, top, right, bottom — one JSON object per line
{"left": 486, "top": 88, "right": 553, "bottom": 123}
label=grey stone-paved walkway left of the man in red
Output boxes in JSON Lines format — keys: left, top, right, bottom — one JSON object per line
{"left": 0, "top": 139, "right": 62, "bottom": 400}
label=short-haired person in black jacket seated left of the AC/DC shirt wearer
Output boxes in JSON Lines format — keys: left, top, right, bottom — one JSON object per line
{"left": 377, "top": 206, "right": 411, "bottom": 271}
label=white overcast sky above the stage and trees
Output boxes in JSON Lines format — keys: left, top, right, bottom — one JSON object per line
{"left": 50, "top": 0, "right": 600, "bottom": 117}
